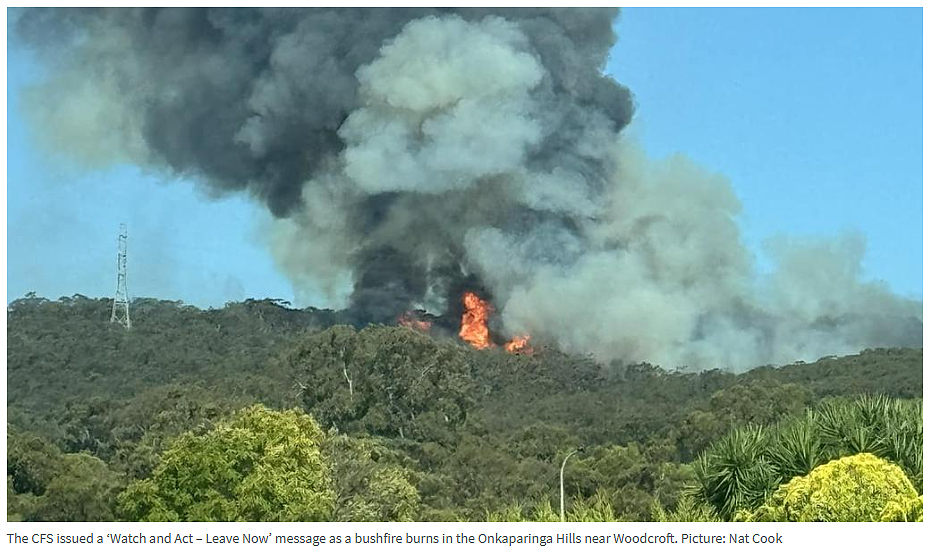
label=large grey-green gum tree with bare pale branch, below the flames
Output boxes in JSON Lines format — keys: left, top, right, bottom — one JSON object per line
{"left": 286, "top": 326, "right": 477, "bottom": 441}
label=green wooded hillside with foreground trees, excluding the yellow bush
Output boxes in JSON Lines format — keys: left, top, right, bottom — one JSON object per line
{"left": 7, "top": 296, "right": 922, "bottom": 520}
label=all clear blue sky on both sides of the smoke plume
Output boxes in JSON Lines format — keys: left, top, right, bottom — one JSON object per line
{"left": 7, "top": 9, "right": 923, "bottom": 306}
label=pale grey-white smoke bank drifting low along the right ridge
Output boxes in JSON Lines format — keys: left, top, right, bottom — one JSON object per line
{"left": 484, "top": 141, "right": 922, "bottom": 369}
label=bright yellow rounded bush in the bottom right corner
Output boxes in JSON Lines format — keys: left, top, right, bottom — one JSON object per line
{"left": 740, "top": 453, "right": 917, "bottom": 522}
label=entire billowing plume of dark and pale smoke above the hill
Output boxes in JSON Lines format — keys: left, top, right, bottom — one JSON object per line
{"left": 16, "top": 9, "right": 922, "bottom": 368}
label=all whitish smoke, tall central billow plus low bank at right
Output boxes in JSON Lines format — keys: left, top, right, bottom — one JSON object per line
{"left": 270, "top": 14, "right": 922, "bottom": 369}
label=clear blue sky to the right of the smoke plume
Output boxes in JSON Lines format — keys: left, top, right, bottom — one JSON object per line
{"left": 608, "top": 9, "right": 923, "bottom": 299}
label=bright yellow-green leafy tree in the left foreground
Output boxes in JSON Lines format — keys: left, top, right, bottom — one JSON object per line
{"left": 119, "top": 406, "right": 334, "bottom": 521}
